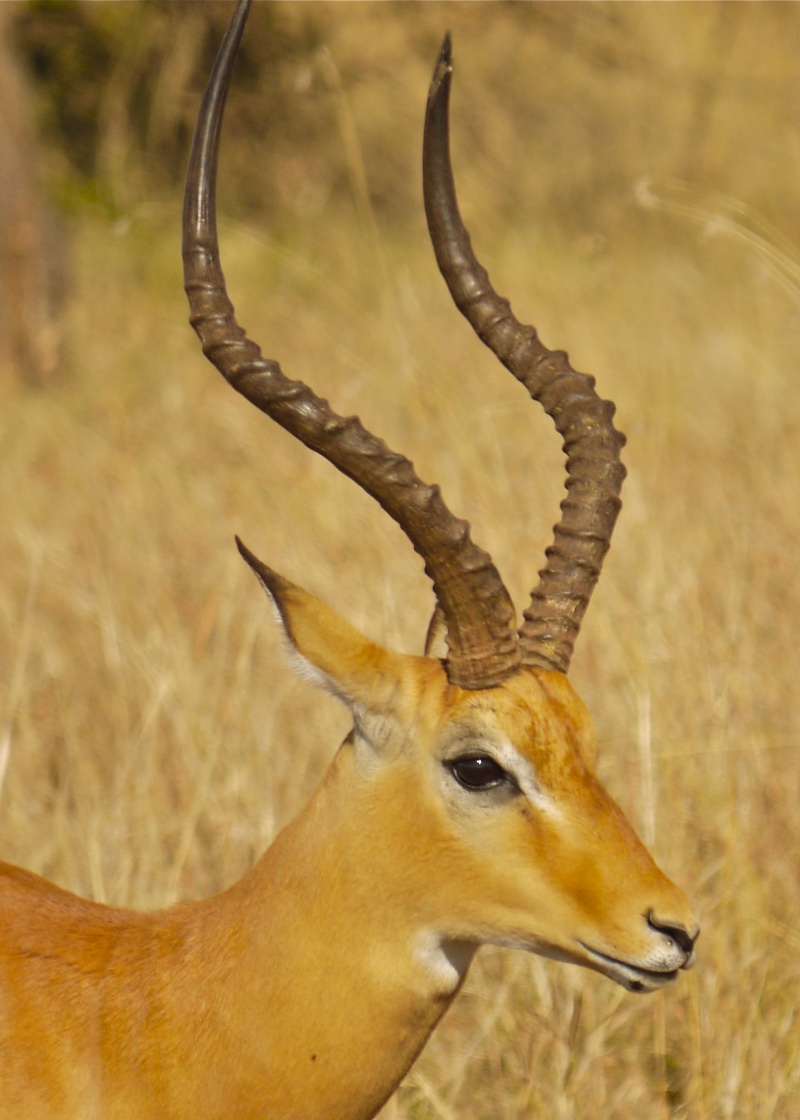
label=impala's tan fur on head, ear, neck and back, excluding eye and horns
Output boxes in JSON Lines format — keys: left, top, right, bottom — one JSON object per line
{"left": 0, "top": 579, "right": 696, "bottom": 1120}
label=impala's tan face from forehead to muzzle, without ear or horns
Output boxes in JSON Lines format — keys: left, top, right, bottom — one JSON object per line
{"left": 367, "top": 670, "right": 697, "bottom": 990}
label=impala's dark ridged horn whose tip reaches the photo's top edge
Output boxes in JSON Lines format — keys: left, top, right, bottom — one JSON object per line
{"left": 184, "top": 0, "right": 520, "bottom": 689}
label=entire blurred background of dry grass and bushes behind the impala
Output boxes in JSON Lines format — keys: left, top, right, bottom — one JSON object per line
{"left": 0, "top": 0, "right": 800, "bottom": 1120}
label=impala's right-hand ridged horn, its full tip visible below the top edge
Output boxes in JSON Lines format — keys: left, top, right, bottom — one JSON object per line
{"left": 422, "top": 35, "right": 625, "bottom": 673}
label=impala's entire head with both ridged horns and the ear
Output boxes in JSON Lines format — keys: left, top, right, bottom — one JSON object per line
{"left": 184, "top": 3, "right": 698, "bottom": 990}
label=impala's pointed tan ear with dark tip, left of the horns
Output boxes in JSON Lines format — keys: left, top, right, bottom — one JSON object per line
{"left": 236, "top": 538, "right": 418, "bottom": 713}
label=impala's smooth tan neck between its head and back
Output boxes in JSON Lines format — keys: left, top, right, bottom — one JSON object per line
{"left": 144, "top": 745, "right": 473, "bottom": 1120}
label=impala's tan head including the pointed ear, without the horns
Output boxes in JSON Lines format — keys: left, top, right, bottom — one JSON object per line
{"left": 250, "top": 575, "right": 698, "bottom": 991}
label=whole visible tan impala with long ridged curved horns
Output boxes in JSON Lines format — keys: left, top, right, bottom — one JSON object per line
{"left": 0, "top": 0, "right": 698, "bottom": 1120}
